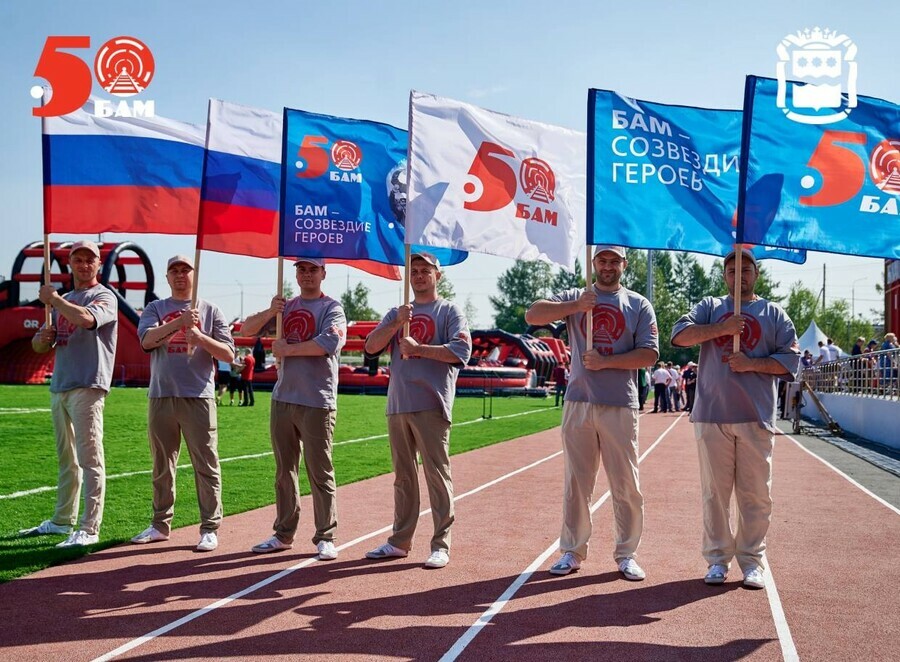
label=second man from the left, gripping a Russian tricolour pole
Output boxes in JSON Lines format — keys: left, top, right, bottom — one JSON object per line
{"left": 131, "top": 255, "right": 234, "bottom": 552}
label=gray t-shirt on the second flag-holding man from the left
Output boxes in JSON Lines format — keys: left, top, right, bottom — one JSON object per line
{"left": 138, "top": 297, "right": 234, "bottom": 398}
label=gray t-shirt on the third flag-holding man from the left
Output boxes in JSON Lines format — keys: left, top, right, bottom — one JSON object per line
{"left": 272, "top": 295, "right": 347, "bottom": 410}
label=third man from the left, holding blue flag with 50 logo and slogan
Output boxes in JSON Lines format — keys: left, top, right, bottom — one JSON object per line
{"left": 241, "top": 257, "right": 347, "bottom": 561}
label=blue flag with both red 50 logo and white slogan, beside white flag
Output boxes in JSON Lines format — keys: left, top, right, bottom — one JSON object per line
{"left": 279, "top": 108, "right": 468, "bottom": 265}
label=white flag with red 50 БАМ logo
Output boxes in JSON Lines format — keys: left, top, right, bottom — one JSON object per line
{"left": 406, "top": 91, "right": 586, "bottom": 269}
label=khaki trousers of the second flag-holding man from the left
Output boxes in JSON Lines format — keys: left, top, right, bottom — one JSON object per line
{"left": 147, "top": 398, "right": 222, "bottom": 535}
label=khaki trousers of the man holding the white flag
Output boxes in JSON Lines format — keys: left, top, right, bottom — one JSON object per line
{"left": 387, "top": 409, "right": 454, "bottom": 552}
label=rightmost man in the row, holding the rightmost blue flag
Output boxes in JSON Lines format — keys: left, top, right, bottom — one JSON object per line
{"left": 672, "top": 249, "right": 800, "bottom": 588}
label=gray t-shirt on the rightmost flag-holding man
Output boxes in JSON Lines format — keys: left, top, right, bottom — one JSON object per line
{"left": 672, "top": 296, "right": 800, "bottom": 431}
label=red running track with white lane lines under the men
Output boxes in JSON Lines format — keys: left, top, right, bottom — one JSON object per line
{"left": 0, "top": 414, "right": 900, "bottom": 660}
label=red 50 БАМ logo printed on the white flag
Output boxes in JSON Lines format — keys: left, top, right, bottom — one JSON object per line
{"left": 463, "top": 142, "right": 558, "bottom": 225}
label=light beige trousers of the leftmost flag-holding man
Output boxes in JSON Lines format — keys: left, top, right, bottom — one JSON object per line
{"left": 50, "top": 388, "right": 106, "bottom": 535}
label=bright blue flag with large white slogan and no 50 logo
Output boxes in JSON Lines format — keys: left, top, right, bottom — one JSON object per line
{"left": 587, "top": 90, "right": 806, "bottom": 263}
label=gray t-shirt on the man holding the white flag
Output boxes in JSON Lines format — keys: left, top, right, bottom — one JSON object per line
{"left": 369, "top": 299, "right": 472, "bottom": 421}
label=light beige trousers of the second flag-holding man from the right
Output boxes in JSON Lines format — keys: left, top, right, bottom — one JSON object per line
{"left": 559, "top": 401, "right": 644, "bottom": 562}
